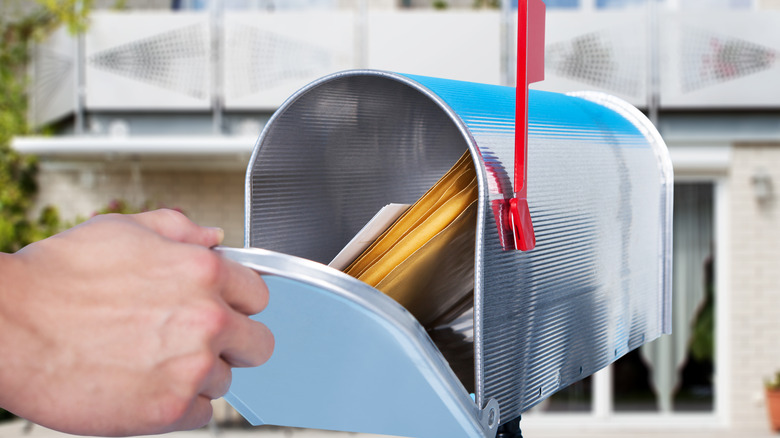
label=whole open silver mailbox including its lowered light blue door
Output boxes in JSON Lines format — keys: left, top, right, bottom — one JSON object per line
{"left": 216, "top": 66, "right": 673, "bottom": 437}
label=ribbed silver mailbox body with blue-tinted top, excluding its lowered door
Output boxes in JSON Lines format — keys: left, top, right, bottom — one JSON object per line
{"left": 247, "top": 71, "right": 672, "bottom": 421}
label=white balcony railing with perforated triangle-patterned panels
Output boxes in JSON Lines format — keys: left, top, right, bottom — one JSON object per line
{"left": 30, "top": 7, "right": 780, "bottom": 124}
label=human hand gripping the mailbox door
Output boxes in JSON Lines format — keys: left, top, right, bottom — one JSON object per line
{"left": 0, "top": 210, "right": 274, "bottom": 436}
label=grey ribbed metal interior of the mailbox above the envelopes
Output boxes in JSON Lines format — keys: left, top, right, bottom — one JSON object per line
{"left": 247, "top": 72, "right": 466, "bottom": 263}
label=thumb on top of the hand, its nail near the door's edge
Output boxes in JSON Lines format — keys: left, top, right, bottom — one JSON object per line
{"left": 127, "top": 209, "right": 225, "bottom": 248}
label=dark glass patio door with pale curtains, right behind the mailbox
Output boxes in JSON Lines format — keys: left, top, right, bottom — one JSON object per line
{"left": 534, "top": 182, "right": 716, "bottom": 415}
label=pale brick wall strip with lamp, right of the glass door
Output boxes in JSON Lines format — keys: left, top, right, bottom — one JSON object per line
{"left": 721, "top": 144, "right": 780, "bottom": 430}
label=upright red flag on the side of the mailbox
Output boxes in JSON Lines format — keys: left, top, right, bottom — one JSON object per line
{"left": 509, "top": 0, "right": 545, "bottom": 251}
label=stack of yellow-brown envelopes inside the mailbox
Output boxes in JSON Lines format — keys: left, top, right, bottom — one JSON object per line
{"left": 344, "top": 151, "right": 478, "bottom": 326}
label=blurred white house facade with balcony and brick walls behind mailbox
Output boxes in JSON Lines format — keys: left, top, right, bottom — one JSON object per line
{"left": 14, "top": 0, "right": 780, "bottom": 436}
